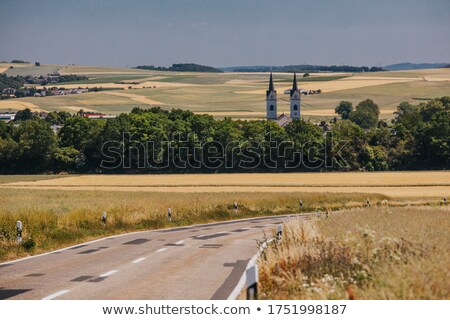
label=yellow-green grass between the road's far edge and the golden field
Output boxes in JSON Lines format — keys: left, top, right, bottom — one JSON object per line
{"left": 0, "top": 188, "right": 386, "bottom": 261}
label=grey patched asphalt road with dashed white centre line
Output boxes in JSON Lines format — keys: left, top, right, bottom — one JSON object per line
{"left": 0, "top": 216, "right": 310, "bottom": 300}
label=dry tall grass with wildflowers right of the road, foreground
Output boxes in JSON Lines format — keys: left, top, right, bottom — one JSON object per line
{"left": 260, "top": 206, "right": 450, "bottom": 299}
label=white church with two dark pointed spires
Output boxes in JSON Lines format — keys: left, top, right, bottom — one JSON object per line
{"left": 266, "top": 72, "right": 300, "bottom": 126}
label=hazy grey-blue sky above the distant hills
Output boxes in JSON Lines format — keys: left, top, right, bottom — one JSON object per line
{"left": 0, "top": 0, "right": 450, "bottom": 67}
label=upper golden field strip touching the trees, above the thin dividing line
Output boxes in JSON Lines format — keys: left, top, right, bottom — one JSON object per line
{"left": 5, "top": 171, "right": 450, "bottom": 187}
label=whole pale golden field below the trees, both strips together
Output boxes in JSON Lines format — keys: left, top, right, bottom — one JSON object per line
{"left": 0, "top": 171, "right": 450, "bottom": 198}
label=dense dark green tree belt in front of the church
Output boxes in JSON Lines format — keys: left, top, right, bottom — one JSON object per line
{"left": 0, "top": 97, "right": 450, "bottom": 173}
